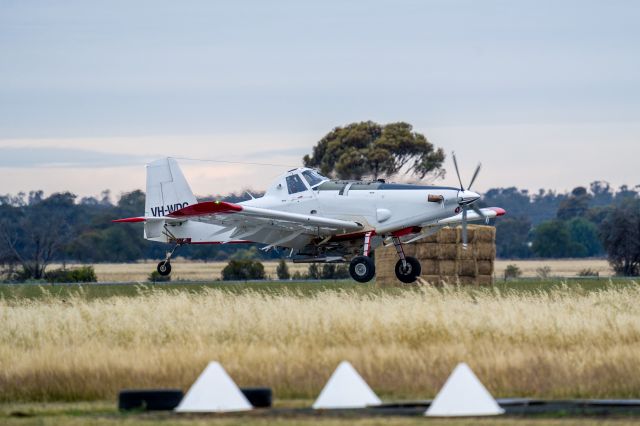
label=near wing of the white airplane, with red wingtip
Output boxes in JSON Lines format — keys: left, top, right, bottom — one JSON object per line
{"left": 168, "top": 201, "right": 363, "bottom": 234}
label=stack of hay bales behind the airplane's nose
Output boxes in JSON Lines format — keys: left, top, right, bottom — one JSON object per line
{"left": 375, "top": 225, "right": 496, "bottom": 286}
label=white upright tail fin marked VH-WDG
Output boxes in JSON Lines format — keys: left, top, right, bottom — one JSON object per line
{"left": 144, "top": 158, "right": 197, "bottom": 217}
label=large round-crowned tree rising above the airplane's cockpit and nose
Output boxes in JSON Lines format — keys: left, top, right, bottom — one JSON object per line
{"left": 303, "top": 121, "right": 445, "bottom": 179}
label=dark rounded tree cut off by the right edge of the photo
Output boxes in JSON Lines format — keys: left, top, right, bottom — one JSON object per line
{"left": 600, "top": 198, "right": 640, "bottom": 276}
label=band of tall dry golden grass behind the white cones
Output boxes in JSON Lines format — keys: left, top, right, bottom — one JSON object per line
{"left": 0, "top": 286, "right": 640, "bottom": 401}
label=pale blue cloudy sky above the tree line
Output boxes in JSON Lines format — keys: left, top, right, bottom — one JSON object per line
{"left": 0, "top": 0, "right": 640, "bottom": 196}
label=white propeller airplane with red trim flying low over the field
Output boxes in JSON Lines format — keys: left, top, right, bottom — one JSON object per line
{"left": 114, "top": 155, "right": 505, "bottom": 283}
